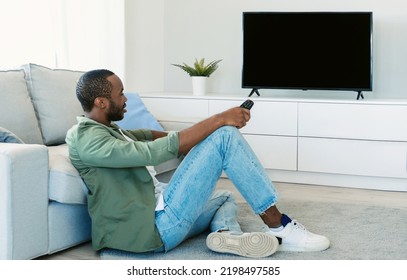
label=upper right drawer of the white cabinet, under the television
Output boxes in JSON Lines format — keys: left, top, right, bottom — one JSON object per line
{"left": 298, "top": 103, "right": 407, "bottom": 141}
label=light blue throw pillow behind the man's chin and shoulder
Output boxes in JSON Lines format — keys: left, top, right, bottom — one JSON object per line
{"left": 116, "top": 93, "right": 164, "bottom": 131}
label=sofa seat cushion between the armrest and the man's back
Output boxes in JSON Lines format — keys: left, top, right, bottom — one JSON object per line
{"left": 48, "top": 144, "right": 87, "bottom": 204}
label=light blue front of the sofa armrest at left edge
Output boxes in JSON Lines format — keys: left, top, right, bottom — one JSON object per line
{"left": 0, "top": 143, "right": 48, "bottom": 259}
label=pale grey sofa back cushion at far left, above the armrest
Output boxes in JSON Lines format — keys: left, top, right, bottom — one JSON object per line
{"left": 0, "top": 70, "right": 43, "bottom": 144}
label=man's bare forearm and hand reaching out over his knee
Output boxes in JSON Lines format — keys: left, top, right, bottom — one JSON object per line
{"left": 178, "top": 107, "right": 250, "bottom": 154}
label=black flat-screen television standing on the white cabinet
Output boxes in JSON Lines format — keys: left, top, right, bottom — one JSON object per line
{"left": 242, "top": 12, "right": 373, "bottom": 99}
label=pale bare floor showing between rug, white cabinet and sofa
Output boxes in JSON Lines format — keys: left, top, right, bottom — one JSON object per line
{"left": 35, "top": 179, "right": 407, "bottom": 260}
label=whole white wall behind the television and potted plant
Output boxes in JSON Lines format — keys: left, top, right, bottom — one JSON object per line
{"left": 126, "top": 0, "right": 407, "bottom": 98}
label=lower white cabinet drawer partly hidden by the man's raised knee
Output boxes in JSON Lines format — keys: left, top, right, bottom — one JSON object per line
{"left": 244, "top": 135, "right": 297, "bottom": 170}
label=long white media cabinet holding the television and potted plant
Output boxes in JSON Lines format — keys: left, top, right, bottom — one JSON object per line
{"left": 141, "top": 93, "right": 407, "bottom": 191}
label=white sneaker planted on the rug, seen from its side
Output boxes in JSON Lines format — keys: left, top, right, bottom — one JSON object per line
{"left": 268, "top": 220, "right": 330, "bottom": 252}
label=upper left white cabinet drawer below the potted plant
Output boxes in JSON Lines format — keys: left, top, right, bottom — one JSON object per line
{"left": 142, "top": 97, "right": 208, "bottom": 122}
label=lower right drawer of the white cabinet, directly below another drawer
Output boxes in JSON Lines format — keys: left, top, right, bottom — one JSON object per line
{"left": 298, "top": 137, "right": 407, "bottom": 178}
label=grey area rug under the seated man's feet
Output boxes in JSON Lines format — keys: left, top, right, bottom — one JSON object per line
{"left": 100, "top": 201, "right": 407, "bottom": 260}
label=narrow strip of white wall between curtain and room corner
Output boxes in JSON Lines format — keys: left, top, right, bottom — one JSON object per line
{"left": 124, "top": 0, "right": 164, "bottom": 92}
